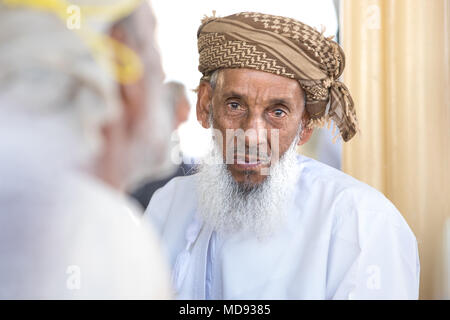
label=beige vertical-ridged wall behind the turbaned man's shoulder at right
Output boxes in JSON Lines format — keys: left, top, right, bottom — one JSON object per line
{"left": 340, "top": 0, "right": 450, "bottom": 299}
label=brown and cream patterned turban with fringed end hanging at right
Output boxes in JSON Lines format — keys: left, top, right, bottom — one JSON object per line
{"left": 197, "top": 12, "right": 358, "bottom": 141}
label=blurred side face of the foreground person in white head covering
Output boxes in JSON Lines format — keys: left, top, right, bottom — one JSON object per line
{"left": 116, "top": 3, "right": 171, "bottom": 186}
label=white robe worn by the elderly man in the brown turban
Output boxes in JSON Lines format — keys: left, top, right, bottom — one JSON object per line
{"left": 146, "top": 156, "right": 420, "bottom": 299}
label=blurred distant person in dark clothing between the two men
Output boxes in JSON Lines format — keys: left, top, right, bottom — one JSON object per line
{"left": 132, "top": 81, "right": 193, "bottom": 209}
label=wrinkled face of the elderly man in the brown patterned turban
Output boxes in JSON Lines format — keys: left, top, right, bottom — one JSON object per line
{"left": 197, "top": 69, "right": 305, "bottom": 185}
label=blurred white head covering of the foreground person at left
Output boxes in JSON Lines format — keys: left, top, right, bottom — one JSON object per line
{"left": 0, "top": 1, "right": 142, "bottom": 162}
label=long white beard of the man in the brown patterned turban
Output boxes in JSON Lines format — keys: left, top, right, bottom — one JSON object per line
{"left": 196, "top": 132, "right": 299, "bottom": 238}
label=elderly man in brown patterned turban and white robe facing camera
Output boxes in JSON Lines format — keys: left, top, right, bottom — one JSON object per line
{"left": 146, "top": 12, "right": 419, "bottom": 299}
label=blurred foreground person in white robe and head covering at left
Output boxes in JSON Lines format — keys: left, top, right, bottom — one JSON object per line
{"left": 0, "top": 0, "right": 171, "bottom": 299}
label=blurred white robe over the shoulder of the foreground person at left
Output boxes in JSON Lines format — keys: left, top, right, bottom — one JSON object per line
{"left": 0, "top": 169, "right": 171, "bottom": 299}
